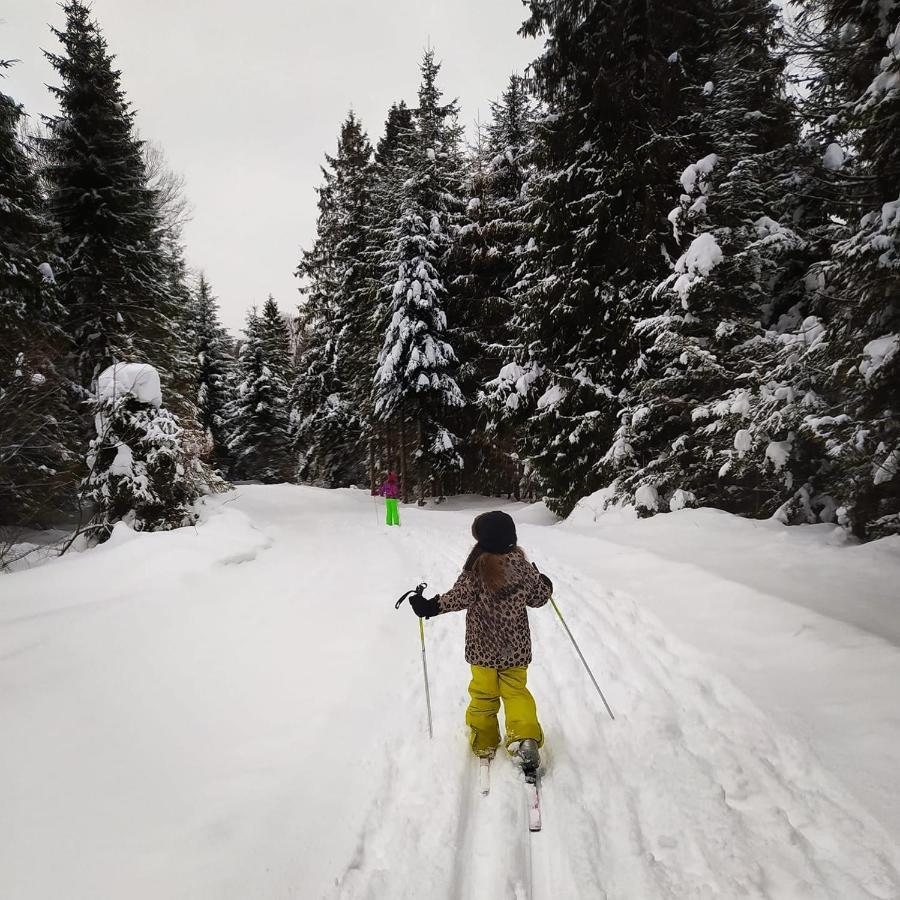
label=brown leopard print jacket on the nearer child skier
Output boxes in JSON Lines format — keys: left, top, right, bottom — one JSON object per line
{"left": 438, "top": 550, "right": 553, "bottom": 669}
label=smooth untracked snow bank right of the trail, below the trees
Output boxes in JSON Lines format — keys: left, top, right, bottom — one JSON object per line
{"left": 556, "top": 496, "right": 900, "bottom": 840}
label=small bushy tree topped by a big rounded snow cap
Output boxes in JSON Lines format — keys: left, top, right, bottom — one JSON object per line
{"left": 83, "top": 363, "right": 203, "bottom": 540}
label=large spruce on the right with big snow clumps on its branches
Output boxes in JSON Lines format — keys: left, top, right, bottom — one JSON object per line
{"left": 605, "top": 0, "right": 818, "bottom": 516}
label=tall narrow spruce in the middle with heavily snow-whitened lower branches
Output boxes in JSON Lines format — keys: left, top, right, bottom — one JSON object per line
{"left": 374, "top": 51, "right": 465, "bottom": 502}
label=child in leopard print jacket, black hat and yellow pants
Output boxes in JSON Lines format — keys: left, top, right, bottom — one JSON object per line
{"left": 410, "top": 512, "right": 553, "bottom": 771}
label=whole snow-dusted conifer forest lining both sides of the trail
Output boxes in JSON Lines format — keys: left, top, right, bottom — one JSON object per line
{"left": 0, "top": 0, "right": 900, "bottom": 540}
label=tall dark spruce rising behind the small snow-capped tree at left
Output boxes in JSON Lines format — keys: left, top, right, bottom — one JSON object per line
{"left": 42, "top": 0, "right": 178, "bottom": 388}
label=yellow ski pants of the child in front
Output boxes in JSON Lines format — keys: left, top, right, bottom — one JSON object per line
{"left": 466, "top": 666, "right": 544, "bottom": 756}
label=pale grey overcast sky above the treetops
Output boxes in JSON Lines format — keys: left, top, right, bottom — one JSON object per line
{"left": 0, "top": 0, "right": 537, "bottom": 331}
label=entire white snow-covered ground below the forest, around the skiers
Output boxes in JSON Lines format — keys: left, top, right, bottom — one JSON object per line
{"left": 0, "top": 486, "right": 900, "bottom": 900}
